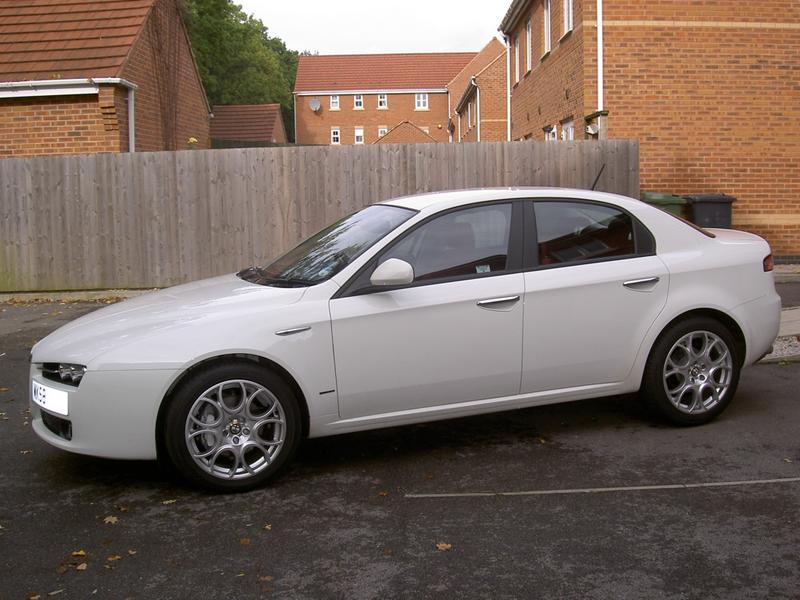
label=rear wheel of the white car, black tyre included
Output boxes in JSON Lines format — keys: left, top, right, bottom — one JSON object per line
{"left": 641, "top": 317, "right": 742, "bottom": 425}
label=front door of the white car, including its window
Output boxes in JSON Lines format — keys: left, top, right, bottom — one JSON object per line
{"left": 330, "top": 202, "right": 523, "bottom": 418}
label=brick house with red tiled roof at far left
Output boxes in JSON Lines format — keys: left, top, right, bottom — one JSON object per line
{"left": 0, "top": 0, "right": 209, "bottom": 157}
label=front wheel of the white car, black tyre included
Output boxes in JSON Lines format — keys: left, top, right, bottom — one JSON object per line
{"left": 163, "top": 362, "right": 302, "bottom": 492}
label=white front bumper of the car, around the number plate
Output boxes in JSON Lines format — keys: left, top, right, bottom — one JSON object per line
{"left": 28, "top": 364, "right": 177, "bottom": 460}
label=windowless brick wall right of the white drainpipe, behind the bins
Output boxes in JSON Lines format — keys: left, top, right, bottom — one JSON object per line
{"left": 604, "top": 0, "right": 800, "bottom": 256}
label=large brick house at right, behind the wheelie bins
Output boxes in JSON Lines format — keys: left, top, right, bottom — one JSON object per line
{"left": 500, "top": 0, "right": 800, "bottom": 258}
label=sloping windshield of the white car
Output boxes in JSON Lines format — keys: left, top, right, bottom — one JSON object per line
{"left": 237, "top": 204, "right": 415, "bottom": 287}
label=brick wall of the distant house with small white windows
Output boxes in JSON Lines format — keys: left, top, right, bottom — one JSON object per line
{"left": 295, "top": 92, "right": 448, "bottom": 144}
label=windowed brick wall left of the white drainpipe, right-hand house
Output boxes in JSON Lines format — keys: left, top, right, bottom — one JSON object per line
{"left": 510, "top": 0, "right": 585, "bottom": 140}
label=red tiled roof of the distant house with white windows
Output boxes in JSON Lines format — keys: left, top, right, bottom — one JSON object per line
{"left": 294, "top": 52, "right": 475, "bottom": 92}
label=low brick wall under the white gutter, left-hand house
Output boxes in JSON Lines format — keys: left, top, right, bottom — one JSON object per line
{"left": 0, "top": 92, "right": 127, "bottom": 157}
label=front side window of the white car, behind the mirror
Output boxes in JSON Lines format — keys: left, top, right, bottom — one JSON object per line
{"left": 377, "top": 204, "right": 511, "bottom": 282}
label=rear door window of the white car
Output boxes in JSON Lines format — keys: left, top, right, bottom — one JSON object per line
{"left": 534, "top": 200, "right": 636, "bottom": 266}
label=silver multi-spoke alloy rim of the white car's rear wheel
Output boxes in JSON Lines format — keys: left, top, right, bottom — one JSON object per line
{"left": 664, "top": 331, "right": 733, "bottom": 414}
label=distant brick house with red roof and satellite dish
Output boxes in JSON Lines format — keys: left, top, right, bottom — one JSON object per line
{"left": 294, "top": 52, "right": 475, "bottom": 145}
